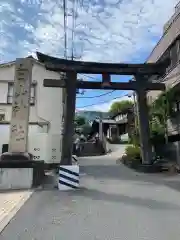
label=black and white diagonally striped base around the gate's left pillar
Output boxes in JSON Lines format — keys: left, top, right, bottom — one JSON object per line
{"left": 58, "top": 165, "right": 79, "bottom": 191}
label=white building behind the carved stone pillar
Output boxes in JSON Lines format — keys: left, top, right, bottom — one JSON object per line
{"left": 0, "top": 58, "right": 63, "bottom": 163}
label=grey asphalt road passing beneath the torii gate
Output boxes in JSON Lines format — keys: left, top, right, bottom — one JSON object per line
{"left": 0, "top": 146, "right": 180, "bottom": 240}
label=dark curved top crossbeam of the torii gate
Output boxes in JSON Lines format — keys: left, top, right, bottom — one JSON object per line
{"left": 37, "top": 52, "right": 167, "bottom": 75}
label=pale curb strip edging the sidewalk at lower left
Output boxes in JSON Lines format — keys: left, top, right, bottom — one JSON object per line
{"left": 0, "top": 190, "right": 34, "bottom": 235}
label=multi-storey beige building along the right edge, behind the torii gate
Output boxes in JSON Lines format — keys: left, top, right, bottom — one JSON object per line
{"left": 147, "top": 3, "right": 180, "bottom": 162}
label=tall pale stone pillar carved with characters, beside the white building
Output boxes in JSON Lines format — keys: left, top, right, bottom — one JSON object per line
{"left": 9, "top": 58, "right": 32, "bottom": 153}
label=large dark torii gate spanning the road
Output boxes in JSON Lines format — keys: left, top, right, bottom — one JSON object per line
{"left": 37, "top": 52, "right": 167, "bottom": 165}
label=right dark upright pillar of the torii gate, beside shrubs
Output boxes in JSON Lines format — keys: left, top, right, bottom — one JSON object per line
{"left": 137, "top": 83, "right": 152, "bottom": 164}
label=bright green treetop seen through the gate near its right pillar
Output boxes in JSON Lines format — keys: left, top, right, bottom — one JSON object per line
{"left": 110, "top": 100, "right": 133, "bottom": 114}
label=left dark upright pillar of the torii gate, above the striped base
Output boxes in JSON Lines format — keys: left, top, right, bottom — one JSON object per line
{"left": 60, "top": 72, "right": 77, "bottom": 165}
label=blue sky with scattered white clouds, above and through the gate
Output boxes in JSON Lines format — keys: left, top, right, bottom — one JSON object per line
{"left": 0, "top": 0, "right": 178, "bottom": 111}
